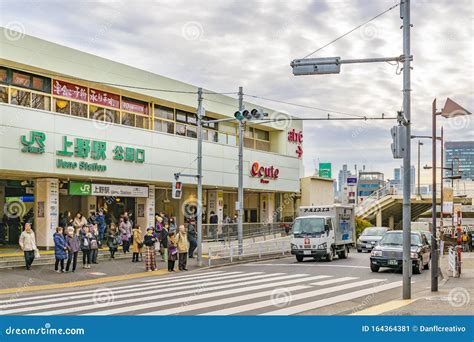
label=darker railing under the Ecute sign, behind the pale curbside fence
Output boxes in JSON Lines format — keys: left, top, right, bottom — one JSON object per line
{"left": 202, "top": 222, "right": 289, "bottom": 242}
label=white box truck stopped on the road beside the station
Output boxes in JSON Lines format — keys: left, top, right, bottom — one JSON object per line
{"left": 291, "top": 204, "right": 356, "bottom": 262}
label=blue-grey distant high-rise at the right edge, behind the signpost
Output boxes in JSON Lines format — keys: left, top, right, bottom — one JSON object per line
{"left": 444, "top": 141, "right": 474, "bottom": 180}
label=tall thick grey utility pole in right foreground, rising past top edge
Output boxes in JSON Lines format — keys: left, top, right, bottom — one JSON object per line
{"left": 400, "top": 0, "right": 412, "bottom": 299}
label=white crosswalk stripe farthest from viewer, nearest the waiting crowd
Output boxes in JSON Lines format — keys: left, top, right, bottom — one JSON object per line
{"left": 0, "top": 272, "right": 260, "bottom": 315}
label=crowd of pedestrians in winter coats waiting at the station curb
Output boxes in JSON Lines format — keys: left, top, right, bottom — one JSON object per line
{"left": 19, "top": 210, "right": 197, "bottom": 273}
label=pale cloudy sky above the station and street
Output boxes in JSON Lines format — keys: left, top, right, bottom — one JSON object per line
{"left": 0, "top": 0, "right": 474, "bottom": 182}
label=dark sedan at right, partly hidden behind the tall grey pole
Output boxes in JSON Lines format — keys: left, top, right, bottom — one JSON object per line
{"left": 370, "top": 230, "right": 431, "bottom": 274}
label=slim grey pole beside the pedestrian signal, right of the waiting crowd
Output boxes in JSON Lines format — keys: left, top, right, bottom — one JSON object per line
{"left": 196, "top": 88, "right": 204, "bottom": 267}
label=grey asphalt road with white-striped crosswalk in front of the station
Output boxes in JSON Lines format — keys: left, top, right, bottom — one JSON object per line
{"left": 0, "top": 253, "right": 430, "bottom": 315}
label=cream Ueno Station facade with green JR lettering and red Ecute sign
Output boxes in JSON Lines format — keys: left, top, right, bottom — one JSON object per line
{"left": 0, "top": 32, "right": 303, "bottom": 247}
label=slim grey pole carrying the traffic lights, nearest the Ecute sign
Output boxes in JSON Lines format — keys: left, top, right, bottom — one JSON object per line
{"left": 237, "top": 87, "right": 245, "bottom": 258}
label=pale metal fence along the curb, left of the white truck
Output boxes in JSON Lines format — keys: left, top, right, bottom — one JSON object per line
{"left": 208, "top": 236, "right": 291, "bottom": 266}
